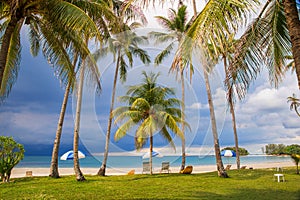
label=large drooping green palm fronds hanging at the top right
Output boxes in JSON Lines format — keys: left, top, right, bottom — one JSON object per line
{"left": 226, "top": 1, "right": 291, "bottom": 99}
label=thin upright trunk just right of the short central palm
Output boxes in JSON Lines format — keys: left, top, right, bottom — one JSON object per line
{"left": 180, "top": 69, "right": 186, "bottom": 171}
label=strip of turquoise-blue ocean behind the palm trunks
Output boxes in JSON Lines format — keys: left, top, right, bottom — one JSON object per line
{"left": 16, "top": 155, "right": 291, "bottom": 168}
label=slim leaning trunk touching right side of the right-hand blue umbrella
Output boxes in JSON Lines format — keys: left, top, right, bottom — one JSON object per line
{"left": 223, "top": 56, "right": 241, "bottom": 169}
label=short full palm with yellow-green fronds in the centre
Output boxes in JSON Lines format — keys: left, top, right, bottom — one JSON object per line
{"left": 113, "top": 71, "right": 188, "bottom": 174}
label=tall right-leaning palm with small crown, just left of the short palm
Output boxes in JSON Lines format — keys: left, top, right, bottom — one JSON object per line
{"left": 95, "top": 2, "right": 150, "bottom": 176}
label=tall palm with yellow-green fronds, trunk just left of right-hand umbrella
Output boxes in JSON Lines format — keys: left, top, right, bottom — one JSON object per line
{"left": 176, "top": 0, "right": 258, "bottom": 177}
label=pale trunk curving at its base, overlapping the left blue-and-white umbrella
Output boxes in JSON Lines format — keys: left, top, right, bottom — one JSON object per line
{"left": 73, "top": 61, "right": 85, "bottom": 181}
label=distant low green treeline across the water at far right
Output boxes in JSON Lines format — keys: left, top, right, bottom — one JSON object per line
{"left": 264, "top": 144, "right": 300, "bottom": 155}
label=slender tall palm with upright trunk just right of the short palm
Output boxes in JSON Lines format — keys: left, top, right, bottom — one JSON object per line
{"left": 149, "top": 5, "right": 193, "bottom": 170}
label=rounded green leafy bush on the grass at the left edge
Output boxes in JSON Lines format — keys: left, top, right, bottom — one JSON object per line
{"left": 0, "top": 136, "right": 24, "bottom": 182}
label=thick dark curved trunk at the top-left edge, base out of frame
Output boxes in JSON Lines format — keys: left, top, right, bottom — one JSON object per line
{"left": 0, "top": 16, "right": 22, "bottom": 91}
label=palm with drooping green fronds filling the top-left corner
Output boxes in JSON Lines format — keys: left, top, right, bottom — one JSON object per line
{"left": 0, "top": 0, "right": 100, "bottom": 100}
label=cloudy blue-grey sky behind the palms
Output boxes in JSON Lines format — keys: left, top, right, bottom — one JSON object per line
{"left": 0, "top": 0, "right": 300, "bottom": 155}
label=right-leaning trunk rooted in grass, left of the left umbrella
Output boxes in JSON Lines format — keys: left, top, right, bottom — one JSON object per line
{"left": 49, "top": 53, "right": 78, "bottom": 178}
